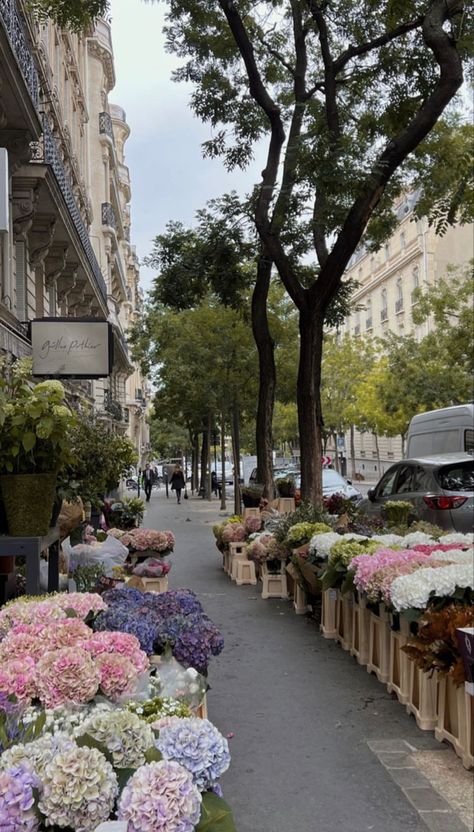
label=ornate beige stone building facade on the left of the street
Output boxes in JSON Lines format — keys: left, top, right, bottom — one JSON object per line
{"left": 0, "top": 0, "right": 148, "bottom": 460}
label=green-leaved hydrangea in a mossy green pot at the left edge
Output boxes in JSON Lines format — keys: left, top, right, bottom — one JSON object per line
{"left": 0, "top": 359, "right": 75, "bottom": 536}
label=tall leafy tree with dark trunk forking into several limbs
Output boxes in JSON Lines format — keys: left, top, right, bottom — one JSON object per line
{"left": 162, "top": 0, "right": 467, "bottom": 501}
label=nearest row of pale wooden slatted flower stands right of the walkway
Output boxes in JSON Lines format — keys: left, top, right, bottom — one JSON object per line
{"left": 321, "top": 589, "right": 474, "bottom": 769}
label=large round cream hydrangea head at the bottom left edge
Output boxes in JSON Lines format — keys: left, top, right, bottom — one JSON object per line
{"left": 38, "top": 745, "right": 118, "bottom": 832}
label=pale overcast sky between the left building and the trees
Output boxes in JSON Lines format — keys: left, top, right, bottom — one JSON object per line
{"left": 109, "top": 0, "right": 262, "bottom": 290}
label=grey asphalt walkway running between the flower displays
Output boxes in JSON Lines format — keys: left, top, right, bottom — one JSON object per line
{"left": 144, "top": 489, "right": 448, "bottom": 832}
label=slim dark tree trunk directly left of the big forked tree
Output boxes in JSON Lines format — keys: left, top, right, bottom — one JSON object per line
{"left": 252, "top": 253, "right": 276, "bottom": 500}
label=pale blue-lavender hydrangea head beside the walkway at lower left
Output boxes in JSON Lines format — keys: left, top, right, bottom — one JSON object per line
{"left": 156, "top": 717, "right": 230, "bottom": 791}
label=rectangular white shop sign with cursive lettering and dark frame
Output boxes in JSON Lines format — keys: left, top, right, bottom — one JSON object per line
{"left": 31, "top": 318, "right": 113, "bottom": 378}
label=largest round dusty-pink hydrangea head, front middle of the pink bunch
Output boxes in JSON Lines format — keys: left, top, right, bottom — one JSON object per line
{"left": 36, "top": 645, "right": 101, "bottom": 708}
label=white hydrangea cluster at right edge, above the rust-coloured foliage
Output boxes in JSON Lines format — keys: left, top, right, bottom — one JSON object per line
{"left": 390, "top": 563, "right": 474, "bottom": 610}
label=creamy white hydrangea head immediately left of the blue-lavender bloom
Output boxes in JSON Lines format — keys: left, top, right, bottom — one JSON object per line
{"left": 76, "top": 709, "right": 155, "bottom": 768}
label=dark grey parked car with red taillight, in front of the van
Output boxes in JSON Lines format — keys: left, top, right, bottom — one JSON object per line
{"left": 359, "top": 452, "right": 474, "bottom": 533}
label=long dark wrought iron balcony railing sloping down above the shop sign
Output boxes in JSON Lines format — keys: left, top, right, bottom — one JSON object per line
{"left": 31, "top": 115, "right": 107, "bottom": 300}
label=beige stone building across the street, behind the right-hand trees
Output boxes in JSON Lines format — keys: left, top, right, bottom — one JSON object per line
{"left": 340, "top": 194, "right": 474, "bottom": 480}
